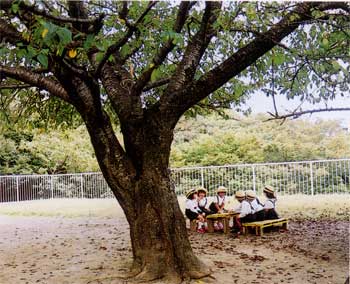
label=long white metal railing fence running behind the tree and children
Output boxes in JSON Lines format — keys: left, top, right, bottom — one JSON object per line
{"left": 0, "top": 159, "right": 350, "bottom": 202}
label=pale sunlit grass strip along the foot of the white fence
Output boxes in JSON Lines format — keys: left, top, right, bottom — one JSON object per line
{"left": 0, "top": 194, "right": 350, "bottom": 220}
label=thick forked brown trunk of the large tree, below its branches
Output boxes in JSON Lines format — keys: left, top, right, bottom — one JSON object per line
{"left": 86, "top": 113, "right": 210, "bottom": 283}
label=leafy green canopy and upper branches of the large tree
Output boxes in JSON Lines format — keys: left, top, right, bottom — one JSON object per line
{"left": 0, "top": 0, "right": 349, "bottom": 123}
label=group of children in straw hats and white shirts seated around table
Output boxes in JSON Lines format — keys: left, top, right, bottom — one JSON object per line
{"left": 185, "top": 185, "right": 279, "bottom": 234}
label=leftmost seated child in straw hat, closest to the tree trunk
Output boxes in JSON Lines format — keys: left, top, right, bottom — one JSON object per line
{"left": 185, "top": 188, "right": 205, "bottom": 233}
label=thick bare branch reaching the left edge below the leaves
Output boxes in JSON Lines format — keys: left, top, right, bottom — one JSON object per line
{"left": 0, "top": 65, "right": 70, "bottom": 102}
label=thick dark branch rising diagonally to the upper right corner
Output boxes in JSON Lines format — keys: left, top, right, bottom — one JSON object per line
{"left": 165, "top": 2, "right": 344, "bottom": 116}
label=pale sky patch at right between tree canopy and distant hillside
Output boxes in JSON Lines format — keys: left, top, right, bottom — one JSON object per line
{"left": 246, "top": 93, "right": 350, "bottom": 129}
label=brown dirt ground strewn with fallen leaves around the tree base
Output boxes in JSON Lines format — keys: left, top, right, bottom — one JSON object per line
{"left": 0, "top": 215, "right": 349, "bottom": 284}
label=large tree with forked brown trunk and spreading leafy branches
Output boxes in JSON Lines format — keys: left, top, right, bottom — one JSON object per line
{"left": 0, "top": 0, "right": 349, "bottom": 281}
